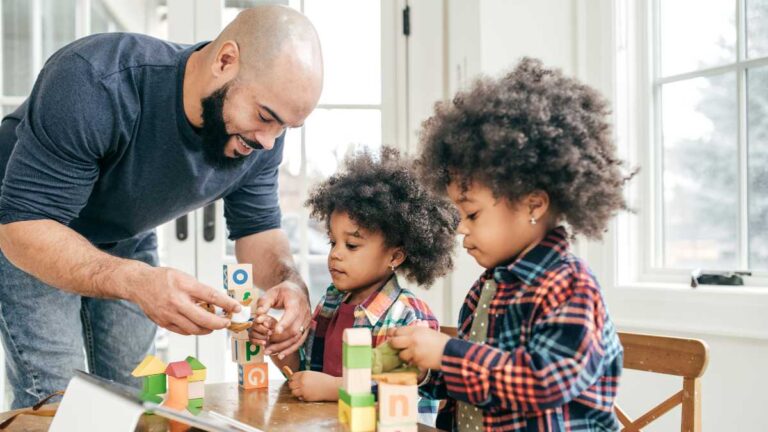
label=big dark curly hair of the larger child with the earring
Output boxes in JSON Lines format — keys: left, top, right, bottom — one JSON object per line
{"left": 417, "top": 58, "right": 634, "bottom": 238}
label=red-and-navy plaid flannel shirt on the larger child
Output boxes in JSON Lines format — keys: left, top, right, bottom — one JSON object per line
{"left": 420, "top": 227, "right": 623, "bottom": 432}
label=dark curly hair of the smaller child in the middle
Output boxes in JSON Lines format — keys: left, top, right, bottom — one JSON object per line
{"left": 305, "top": 147, "right": 459, "bottom": 285}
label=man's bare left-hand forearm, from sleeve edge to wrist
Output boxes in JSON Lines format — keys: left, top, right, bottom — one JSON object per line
{"left": 0, "top": 220, "right": 148, "bottom": 299}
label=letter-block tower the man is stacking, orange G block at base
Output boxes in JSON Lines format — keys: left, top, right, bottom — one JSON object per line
{"left": 224, "top": 264, "right": 269, "bottom": 390}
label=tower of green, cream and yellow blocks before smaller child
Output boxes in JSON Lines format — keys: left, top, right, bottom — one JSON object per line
{"left": 339, "top": 328, "right": 376, "bottom": 432}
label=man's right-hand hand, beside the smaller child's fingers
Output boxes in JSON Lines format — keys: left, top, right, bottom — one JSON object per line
{"left": 254, "top": 281, "right": 312, "bottom": 359}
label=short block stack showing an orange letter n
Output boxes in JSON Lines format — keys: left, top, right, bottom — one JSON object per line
{"left": 373, "top": 372, "right": 419, "bottom": 432}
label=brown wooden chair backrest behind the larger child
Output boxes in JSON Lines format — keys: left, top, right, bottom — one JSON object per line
{"left": 615, "top": 332, "right": 709, "bottom": 432}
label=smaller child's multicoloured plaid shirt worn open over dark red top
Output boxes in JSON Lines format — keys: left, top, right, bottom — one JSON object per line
{"left": 302, "top": 276, "right": 440, "bottom": 425}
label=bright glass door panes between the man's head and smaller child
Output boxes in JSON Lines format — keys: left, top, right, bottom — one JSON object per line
{"left": 224, "top": 0, "right": 385, "bottom": 305}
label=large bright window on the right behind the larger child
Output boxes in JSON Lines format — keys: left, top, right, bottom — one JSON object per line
{"left": 644, "top": 0, "right": 768, "bottom": 273}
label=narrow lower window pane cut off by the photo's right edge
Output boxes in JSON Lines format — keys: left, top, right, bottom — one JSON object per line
{"left": 747, "top": 67, "right": 768, "bottom": 270}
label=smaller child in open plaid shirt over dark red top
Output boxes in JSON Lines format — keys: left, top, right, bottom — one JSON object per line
{"left": 252, "top": 148, "right": 458, "bottom": 413}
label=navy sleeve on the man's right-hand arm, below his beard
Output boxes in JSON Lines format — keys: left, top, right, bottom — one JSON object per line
{"left": 224, "top": 134, "right": 285, "bottom": 240}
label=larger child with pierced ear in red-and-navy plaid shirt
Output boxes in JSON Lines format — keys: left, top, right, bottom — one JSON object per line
{"left": 390, "top": 59, "right": 631, "bottom": 431}
